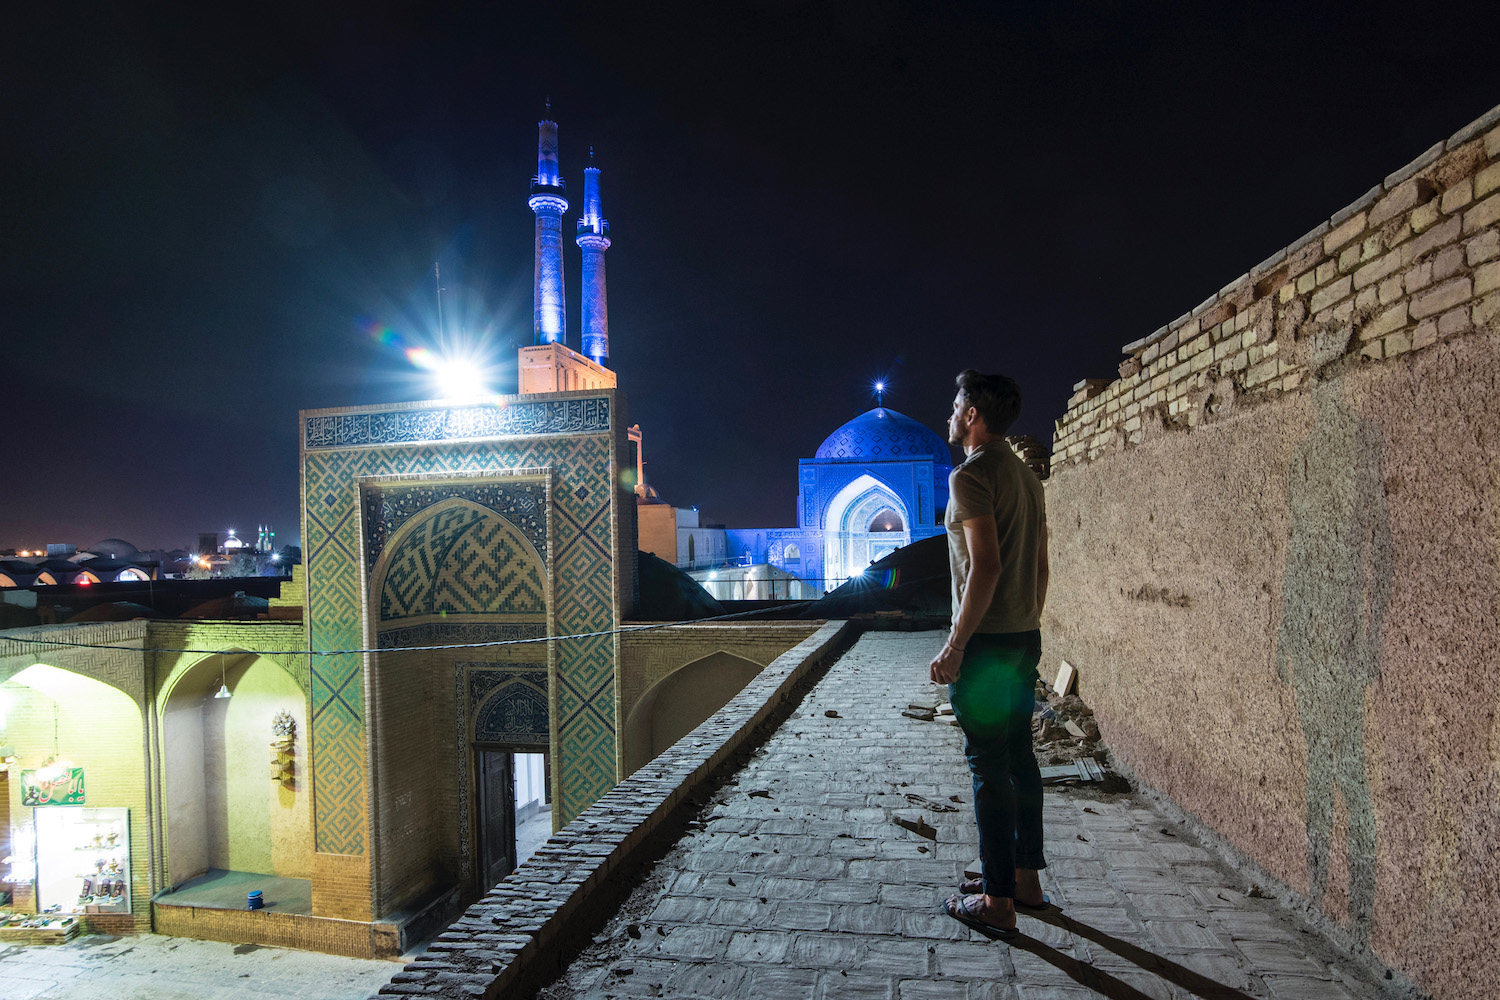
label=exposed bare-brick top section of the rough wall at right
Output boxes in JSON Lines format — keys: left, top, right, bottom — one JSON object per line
{"left": 1053, "top": 105, "right": 1500, "bottom": 468}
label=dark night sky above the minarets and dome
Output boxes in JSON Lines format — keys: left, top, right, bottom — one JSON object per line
{"left": 11, "top": 0, "right": 1500, "bottom": 549}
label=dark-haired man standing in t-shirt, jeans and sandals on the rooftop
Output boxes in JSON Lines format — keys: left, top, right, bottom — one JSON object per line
{"left": 930, "top": 369, "right": 1050, "bottom": 939}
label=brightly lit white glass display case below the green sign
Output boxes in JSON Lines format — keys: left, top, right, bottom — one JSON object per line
{"left": 36, "top": 805, "right": 131, "bottom": 913}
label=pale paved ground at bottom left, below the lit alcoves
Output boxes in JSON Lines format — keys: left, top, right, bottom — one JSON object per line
{"left": 0, "top": 934, "right": 401, "bottom": 1000}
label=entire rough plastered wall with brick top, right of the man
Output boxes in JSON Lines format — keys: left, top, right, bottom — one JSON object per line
{"left": 1043, "top": 108, "right": 1500, "bottom": 999}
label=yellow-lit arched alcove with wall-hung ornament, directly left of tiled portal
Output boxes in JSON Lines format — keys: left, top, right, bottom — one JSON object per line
{"left": 162, "top": 649, "right": 312, "bottom": 886}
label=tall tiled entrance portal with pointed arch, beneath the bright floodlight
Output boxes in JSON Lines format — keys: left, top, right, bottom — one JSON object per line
{"left": 302, "top": 390, "right": 635, "bottom": 919}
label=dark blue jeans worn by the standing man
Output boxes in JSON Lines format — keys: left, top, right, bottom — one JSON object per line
{"left": 948, "top": 631, "right": 1047, "bottom": 898}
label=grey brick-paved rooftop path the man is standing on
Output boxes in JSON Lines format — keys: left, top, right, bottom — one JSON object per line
{"left": 539, "top": 633, "right": 1382, "bottom": 1000}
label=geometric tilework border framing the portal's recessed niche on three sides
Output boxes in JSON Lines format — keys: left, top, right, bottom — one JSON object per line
{"left": 303, "top": 397, "right": 617, "bottom": 855}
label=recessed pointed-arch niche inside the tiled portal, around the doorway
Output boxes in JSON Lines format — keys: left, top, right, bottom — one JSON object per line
{"left": 363, "top": 472, "right": 555, "bottom": 912}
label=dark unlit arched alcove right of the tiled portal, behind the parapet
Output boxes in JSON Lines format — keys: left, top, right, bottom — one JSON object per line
{"left": 621, "top": 649, "right": 765, "bottom": 775}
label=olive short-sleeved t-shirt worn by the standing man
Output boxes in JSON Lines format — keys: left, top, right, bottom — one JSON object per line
{"left": 944, "top": 438, "right": 1047, "bottom": 633}
